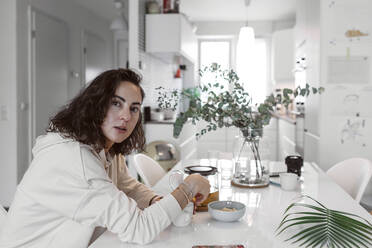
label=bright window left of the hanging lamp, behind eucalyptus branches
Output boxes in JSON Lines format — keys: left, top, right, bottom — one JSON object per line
{"left": 199, "top": 40, "right": 231, "bottom": 100}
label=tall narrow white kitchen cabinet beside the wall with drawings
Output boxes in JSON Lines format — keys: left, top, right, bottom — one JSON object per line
{"left": 294, "top": 0, "right": 321, "bottom": 164}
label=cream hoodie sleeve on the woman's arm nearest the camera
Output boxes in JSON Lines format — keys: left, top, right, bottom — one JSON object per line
{"left": 74, "top": 145, "right": 181, "bottom": 244}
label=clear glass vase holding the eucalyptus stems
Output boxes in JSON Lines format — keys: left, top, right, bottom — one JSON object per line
{"left": 232, "top": 128, "right": 269, "bottom": 188}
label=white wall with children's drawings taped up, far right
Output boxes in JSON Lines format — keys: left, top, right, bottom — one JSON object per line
{"left": 319, "top": 0, "right": 372, "bottom": 170}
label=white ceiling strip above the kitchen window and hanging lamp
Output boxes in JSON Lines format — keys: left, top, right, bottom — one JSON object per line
{"left": 180, "top": 0, "right": 296, "bottom": 21}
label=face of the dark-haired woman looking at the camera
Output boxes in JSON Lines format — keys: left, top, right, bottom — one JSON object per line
{"left": 101, "top": 81, "right": 142, "bottom": 150}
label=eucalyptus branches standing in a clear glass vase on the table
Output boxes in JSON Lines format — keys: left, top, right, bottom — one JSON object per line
{"left": 158, "top": 63, "right": 324, "bottom": 187}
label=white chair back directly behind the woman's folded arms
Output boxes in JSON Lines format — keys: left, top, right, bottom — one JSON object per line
{"left": 133, "top": 153, "right": 166, "bottom": 187}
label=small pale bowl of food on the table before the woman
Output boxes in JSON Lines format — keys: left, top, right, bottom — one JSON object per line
{"left": 208, "top": 201, "right": 245, "bottom": 222}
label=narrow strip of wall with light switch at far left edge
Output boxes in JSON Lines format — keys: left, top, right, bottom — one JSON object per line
{"left": 0, "top": 0, "right": 18, "bottom": 209}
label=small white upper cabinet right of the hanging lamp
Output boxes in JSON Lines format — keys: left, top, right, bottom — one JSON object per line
{"left": 272, "top": 29, "right": 295, "bottom": 84}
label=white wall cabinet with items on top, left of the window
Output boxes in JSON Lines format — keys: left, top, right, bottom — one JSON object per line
{"left": 146, "top": 14, "right": 197, "bottom": 63}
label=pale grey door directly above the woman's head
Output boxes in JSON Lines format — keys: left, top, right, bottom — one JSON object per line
{"left": 83, "top": 31, "right": 109, "bottom": 83}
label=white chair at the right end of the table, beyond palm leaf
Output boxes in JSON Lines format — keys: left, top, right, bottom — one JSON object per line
{"left": 327, "top": 158, "right": 372, "bottom": 203}
